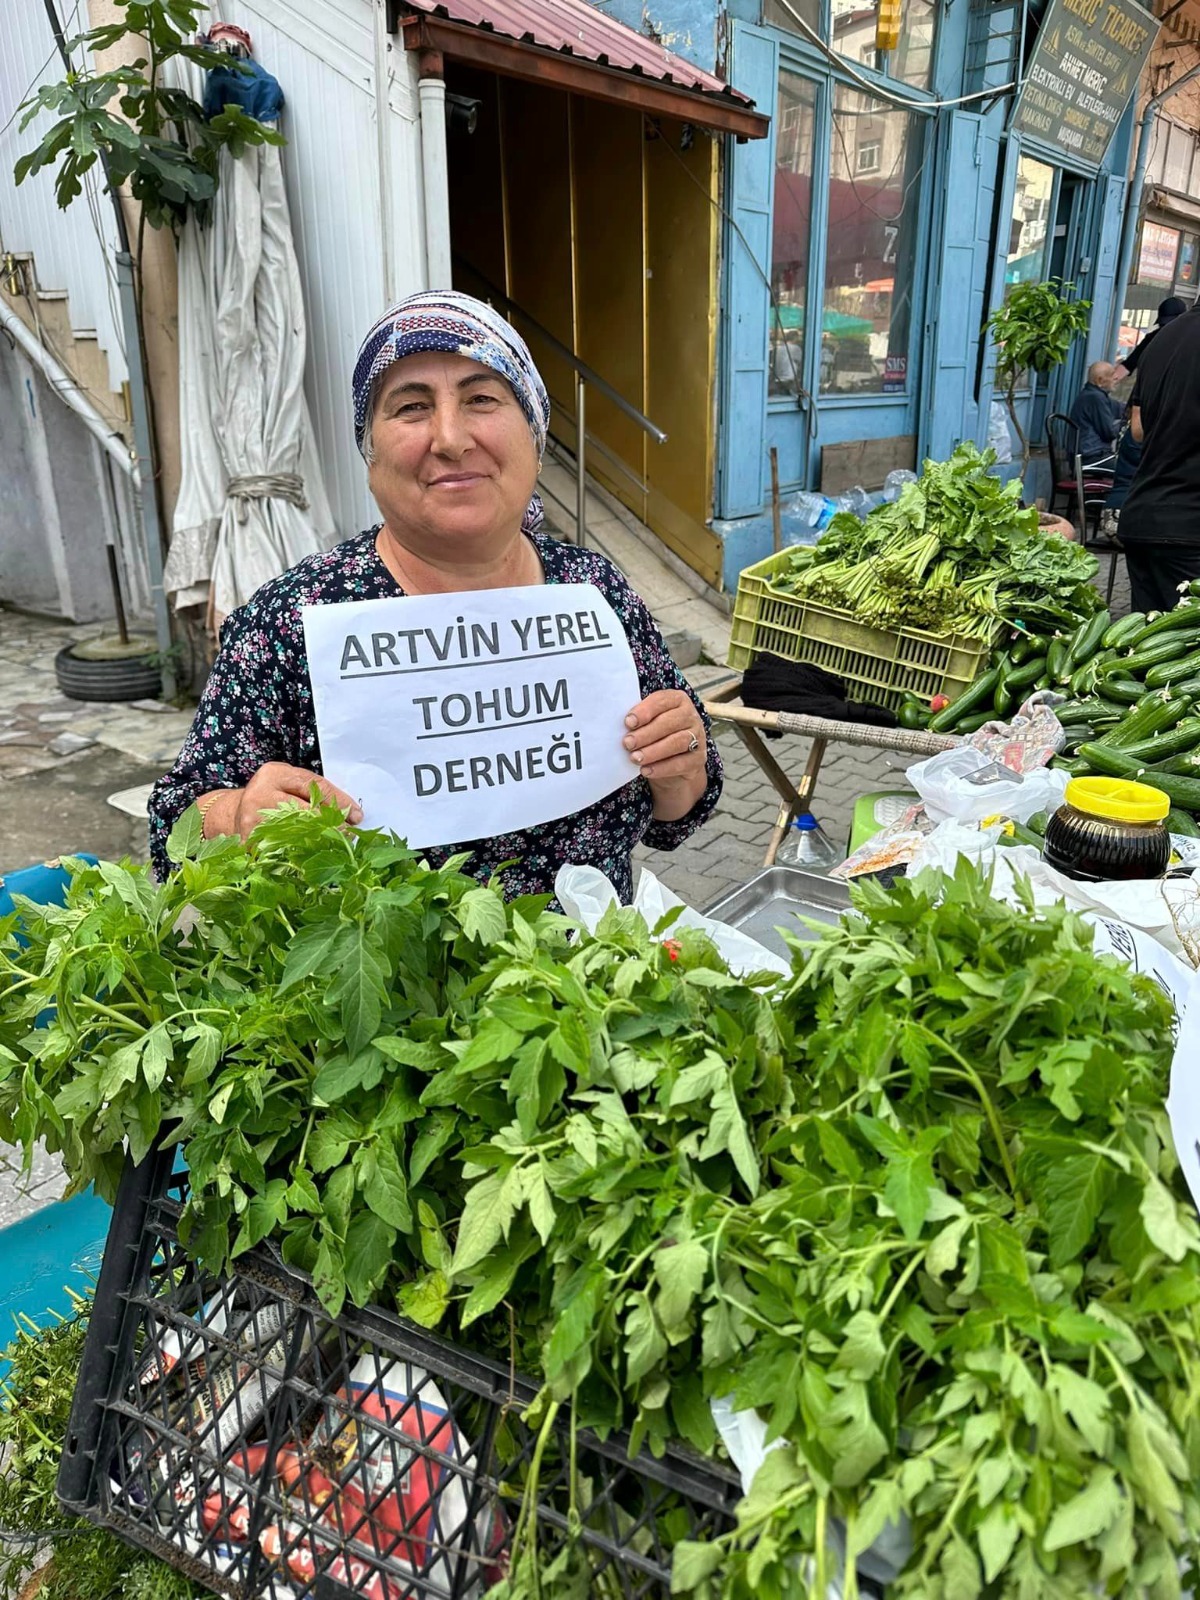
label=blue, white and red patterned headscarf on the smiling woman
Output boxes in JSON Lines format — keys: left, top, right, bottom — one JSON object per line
{"left": 354, "top": 290, "right": 550, "bottom": 459}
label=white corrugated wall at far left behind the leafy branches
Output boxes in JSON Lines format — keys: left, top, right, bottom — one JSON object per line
{"left": 0, "top": 0, "right": 126, "bottom": 392}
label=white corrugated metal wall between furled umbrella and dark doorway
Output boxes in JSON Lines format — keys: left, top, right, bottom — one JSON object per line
{"left": 213, "top": 0, "right": 426, "bottom": 538}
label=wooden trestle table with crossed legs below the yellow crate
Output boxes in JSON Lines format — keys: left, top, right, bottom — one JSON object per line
{"left": 704, "top": 674, "right": 960, "bottom": 867}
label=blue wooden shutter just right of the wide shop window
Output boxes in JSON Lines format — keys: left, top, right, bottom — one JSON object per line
{"left": 920, "top": 110, "right": 1000, "bottom": 461}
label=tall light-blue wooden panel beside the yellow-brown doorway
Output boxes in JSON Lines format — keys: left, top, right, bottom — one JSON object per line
{"left": 717, "top": 22, "right": 779, "bottom": 517}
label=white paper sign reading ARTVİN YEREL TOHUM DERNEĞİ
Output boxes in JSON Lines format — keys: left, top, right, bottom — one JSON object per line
{"left": 302, "top": 584, "right": 642, "bottom": 850}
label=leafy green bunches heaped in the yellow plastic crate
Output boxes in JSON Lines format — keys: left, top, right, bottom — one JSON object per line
{"left": 774, "top": 443, "right": 1099, "bottom": 640}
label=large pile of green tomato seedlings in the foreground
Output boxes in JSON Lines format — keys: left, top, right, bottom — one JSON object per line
{"left": 0, "top": 808, "right": 1200, "bottom": 1600}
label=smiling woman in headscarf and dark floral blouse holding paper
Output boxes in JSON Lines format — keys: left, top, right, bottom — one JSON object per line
{"left": 149, "top": 291, "right": 722, "bottom": 901}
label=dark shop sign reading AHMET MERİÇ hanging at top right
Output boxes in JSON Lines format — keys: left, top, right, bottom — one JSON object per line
{"left": 1013, "top": 0, "right": 1158, "bottom": 166}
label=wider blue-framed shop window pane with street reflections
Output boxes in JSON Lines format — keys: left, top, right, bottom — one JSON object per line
{"left": 821, "top": 88, "right": 925, "bottom": 395}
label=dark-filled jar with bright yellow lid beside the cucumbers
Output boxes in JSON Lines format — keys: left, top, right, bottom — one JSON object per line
{"left": 1042, "top": 778, "right": 1171, "bottom": 883}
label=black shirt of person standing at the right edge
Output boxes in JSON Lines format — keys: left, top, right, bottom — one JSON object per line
{"left": 1122, "top": 310, "right": 1200, "bottom": 547}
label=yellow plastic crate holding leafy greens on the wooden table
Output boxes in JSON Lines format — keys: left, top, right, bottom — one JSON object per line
{"left": 730, "top": 550, "right": 992, "bottom": 710}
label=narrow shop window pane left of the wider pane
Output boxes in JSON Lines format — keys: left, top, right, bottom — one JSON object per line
{"left": 770, "top": 72, "right": 816, "bottom": 395}
